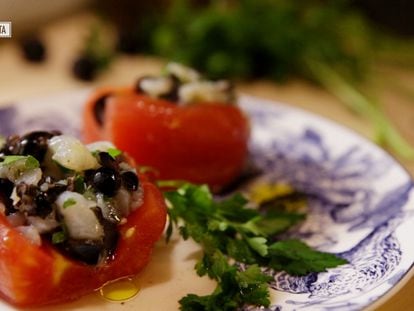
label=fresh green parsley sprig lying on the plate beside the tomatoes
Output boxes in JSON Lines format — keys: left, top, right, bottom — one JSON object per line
{"left": 165, "top": 184, "right": 346, "bottom": 310}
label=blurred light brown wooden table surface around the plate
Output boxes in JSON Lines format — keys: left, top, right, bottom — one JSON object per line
{"left": 0, "top": 13, "right": 414, "bottom": 311}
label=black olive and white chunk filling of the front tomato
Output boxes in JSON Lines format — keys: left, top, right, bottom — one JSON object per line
{"left": 0, "top": 131, "right": 142, "bottom": 265}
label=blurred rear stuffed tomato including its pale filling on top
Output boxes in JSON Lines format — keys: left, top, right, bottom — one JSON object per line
{"left": 83, "top": 64, "right": 250, "bottom": 190}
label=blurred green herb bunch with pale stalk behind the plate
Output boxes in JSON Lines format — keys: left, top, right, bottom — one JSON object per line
{"left": 95, "top": 0, "right": 414, "bottom": 158}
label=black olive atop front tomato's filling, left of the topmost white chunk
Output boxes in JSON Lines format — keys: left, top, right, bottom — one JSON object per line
{"left": 19, "top": 131, "right": 60, "bottom": 162}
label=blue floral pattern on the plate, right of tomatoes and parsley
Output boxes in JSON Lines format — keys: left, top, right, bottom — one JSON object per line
{"left": 241, "top": 98, "right": 414, "bottom": 310}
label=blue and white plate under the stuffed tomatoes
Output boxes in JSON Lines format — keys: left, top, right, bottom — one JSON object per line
{"left": 0, "top": 91, "right": 414, "bottom": 311}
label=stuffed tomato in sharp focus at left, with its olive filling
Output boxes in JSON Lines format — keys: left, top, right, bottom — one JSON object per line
{"left": 0, "top": 132, "right": 166, "bottom": 307}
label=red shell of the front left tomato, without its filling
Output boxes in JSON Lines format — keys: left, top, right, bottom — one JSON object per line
{"left": 0, "top": 181, "right": 166, "bottom": 307}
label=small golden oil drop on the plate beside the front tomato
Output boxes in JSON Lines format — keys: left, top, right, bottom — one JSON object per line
{"left": 99, "top": 278, "right": 140, "bottom": 301}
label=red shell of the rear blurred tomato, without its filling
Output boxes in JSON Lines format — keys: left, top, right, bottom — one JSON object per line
{"left": 83, "top": 89, "right": 249, "bottom": 193}
